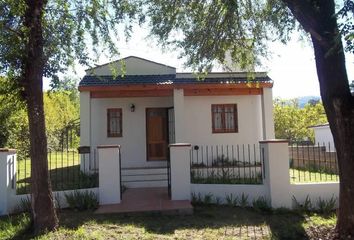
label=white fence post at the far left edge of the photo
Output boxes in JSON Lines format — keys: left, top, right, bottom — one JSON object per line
{"left": 0, "top": 148, "right": 16, "bottom": 216}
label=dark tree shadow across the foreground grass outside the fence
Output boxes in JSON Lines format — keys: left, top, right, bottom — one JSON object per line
{"left": 54, "top": 206, "right": 308, "bottom": 239}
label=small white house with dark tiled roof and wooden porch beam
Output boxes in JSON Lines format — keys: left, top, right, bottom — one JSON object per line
{"left": 79, "top": 56, "right": 274, "bottom": 187}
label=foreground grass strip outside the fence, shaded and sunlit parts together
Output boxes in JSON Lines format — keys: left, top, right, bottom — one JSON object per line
{"left": 0, "top": 206, "right": 336, "bottom": 240}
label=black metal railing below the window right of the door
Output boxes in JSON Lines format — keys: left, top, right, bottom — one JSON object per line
{"left": 190, "top": 144, "right": 264, "bottom": 184}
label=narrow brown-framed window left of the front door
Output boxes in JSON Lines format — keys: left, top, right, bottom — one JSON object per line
{"left": 107, "top": 108, "right": 122, "bottom": 137}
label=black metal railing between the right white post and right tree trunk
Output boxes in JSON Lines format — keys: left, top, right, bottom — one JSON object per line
{"left": 289, "top": 143, "right": 339, "bottom": 183}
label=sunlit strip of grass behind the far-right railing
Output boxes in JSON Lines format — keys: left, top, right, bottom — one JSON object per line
{"left": 290, "top": 168, "right": 339, "bottom": 183}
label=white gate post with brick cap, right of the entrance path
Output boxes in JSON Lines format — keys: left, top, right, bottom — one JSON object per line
{"left": 170, "top": 143, "right": 191, "bottom": 200}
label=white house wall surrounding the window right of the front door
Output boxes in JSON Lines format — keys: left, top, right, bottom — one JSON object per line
{"left": 183, "top": 95, "right": 262, "bottom": 145}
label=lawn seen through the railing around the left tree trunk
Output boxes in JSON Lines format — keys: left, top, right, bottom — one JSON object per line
{"left": 16, "top": 151, "right": 97, "bottom": 194}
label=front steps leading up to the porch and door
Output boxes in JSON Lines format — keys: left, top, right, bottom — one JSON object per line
{"left": 121, "top": 167, "right": 168, "bottom": 188}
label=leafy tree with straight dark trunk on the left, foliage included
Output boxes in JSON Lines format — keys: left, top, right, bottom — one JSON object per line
{"left": 0, "top": 0, "right": 139, "bottom": 233}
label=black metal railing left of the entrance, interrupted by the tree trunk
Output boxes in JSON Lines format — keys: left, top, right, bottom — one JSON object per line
{"left": 16, "top": 149, "right": 98, "bottom": 194}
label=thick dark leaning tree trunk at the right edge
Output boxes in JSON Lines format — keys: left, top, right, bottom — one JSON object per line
{"left": 284, "top": 0, "right": 354, "bottom": 239}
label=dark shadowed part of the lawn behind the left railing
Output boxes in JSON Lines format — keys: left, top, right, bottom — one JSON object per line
{"left": 16, "top": 165, "right": 98, "bottom": 194}
